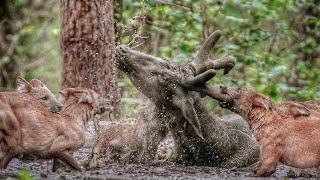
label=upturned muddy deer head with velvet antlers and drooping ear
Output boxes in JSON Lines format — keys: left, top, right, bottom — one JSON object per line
{"left": 115, "top": 31, "right": 235, "bottom": 139}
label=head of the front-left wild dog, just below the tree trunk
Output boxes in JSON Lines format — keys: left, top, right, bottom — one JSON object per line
{"left": 59, "top": 87, "right": 100, "bottom": 110}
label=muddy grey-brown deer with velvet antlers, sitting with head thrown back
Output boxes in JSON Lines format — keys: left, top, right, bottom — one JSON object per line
{"left": 115, "top": 31, "right": 259, "bottom": 168}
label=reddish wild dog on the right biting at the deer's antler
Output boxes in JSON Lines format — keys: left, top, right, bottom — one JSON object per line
{"left": 222, "top": 87, "right": 320, "bottom": 176}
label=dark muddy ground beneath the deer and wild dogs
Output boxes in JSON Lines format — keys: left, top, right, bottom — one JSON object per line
{"left": 0, "top": 121, "right": 320, "bottom": 179}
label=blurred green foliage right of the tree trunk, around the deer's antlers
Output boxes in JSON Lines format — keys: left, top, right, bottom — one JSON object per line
{"left": 118, "top": 0, "right": 320, "bottom": 107}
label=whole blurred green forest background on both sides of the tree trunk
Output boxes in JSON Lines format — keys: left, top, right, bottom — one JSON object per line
{"left": 0, "top": 0, "right": 320, "bottom": 119}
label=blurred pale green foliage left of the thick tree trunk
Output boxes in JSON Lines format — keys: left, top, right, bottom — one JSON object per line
{"left": 4, "top": 0, "right": 61, "bottom": 92}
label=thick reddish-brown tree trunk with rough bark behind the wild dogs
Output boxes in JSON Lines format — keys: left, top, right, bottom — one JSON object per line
{"left": 61, "top": 0, "right": 120, "bottom": 117}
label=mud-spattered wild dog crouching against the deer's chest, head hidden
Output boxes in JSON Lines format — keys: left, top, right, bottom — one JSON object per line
{"left": 89, "top": 104, "right": 166, "bottom": 169}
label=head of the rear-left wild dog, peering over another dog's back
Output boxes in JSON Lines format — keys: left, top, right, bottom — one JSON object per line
{"left": 16, "top": 76, "right": 62, "bottom": 112}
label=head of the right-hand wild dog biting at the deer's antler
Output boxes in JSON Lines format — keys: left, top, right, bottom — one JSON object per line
{"left": 220, "top": 87, "right": 273, "bottom": 116}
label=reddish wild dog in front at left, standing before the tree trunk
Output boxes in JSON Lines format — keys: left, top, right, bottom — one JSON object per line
{"left": 0, "top": 87, "right": 99, "bottom": 170}
